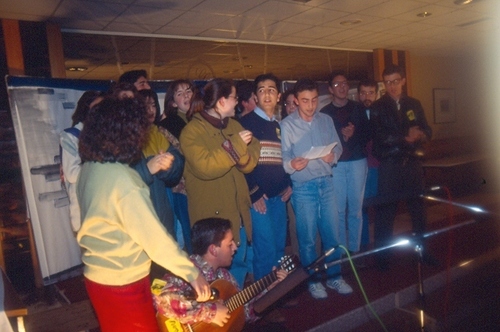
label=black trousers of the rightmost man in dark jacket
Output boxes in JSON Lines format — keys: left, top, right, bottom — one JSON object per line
{"left": 374, "top": 158, "right": 426, "bottom": 253}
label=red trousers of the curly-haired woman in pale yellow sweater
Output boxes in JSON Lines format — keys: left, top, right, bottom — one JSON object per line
{"left": 85, "top": 276, "right": 159, "bottom": 332}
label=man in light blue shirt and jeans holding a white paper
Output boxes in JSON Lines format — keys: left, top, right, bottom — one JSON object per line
{"left": 281, "top": 79, "right": 352, "bottom": 299}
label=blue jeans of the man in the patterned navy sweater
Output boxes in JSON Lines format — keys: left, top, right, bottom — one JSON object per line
{"left": 250, "top": 196, "right": 286, "bottom": 280}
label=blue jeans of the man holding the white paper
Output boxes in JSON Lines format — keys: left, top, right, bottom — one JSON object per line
{"left": 292, "top": 176, "right": 342, "bottom": 279}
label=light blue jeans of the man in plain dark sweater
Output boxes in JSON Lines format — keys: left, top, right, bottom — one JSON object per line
{"left": 333, "top": 158, "right": 368, "bottom": 252}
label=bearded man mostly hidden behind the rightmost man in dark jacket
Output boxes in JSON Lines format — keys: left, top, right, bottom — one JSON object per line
{"left": 358, "top": 79, "right": 380, "bottom": 249}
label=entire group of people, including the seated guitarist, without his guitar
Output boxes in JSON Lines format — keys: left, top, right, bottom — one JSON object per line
{"left": 61, "top": 66, "right": 430, "bottom": 331}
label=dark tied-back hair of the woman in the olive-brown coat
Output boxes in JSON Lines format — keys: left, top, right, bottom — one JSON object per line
{"left": 189, "top": 78, "right": 235, "bottom": 114}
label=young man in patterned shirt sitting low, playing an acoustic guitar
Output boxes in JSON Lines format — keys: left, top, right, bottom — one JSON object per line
{"left": 153, "top": 218, "right": 288, "bottom": 331}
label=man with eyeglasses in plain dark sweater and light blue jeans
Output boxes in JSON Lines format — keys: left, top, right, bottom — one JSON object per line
{"left": 320, "top": 71, "right": 369, "bottom": 252}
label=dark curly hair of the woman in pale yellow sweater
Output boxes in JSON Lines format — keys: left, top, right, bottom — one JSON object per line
{"left": 79, "top": 97, "right": 149, "bottom": 164}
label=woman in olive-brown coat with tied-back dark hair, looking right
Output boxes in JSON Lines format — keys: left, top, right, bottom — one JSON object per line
{"left": 180, "top": 78, "right": 260, "bottom": 287}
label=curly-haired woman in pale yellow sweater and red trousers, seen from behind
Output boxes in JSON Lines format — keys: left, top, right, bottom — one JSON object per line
{"left": 77, "top": 98, "right": 210, "bottom": 331}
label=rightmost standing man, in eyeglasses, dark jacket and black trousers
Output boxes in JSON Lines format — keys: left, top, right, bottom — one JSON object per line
{"left": 371, "top": 65, "right": 432, "bottom": 270}
